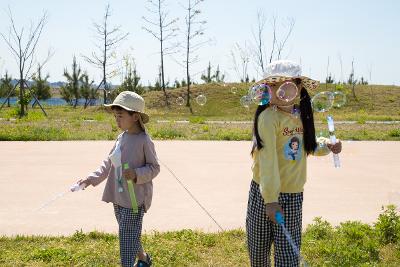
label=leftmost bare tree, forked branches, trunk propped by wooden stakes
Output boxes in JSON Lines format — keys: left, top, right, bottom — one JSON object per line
{"left": 0, "top": 9, "right": 51, "bottom": 117}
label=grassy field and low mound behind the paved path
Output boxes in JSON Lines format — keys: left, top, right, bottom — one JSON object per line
{"left": 0, "top": 84, "right": 400, "bottom": 141}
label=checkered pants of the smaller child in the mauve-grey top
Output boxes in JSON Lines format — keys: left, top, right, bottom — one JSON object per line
{"left": 114, "top": 204, "right": 144, "bottom": 267}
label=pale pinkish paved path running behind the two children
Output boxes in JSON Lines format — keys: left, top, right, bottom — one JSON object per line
{"left": 0, "top": 141, "right": 400, "bottom": 235}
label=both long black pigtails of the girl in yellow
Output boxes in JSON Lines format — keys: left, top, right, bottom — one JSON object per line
{"left": 251, "top": 82, "right": 317, "bottom": 155}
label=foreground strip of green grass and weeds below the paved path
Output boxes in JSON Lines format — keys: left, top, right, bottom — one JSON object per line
{"left": 0, "top": 206, "right": 400, "bottom": 266}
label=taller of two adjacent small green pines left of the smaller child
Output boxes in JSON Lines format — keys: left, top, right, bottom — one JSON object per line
{"left": 61, "top": 56, "right": 84, "bottom": 108}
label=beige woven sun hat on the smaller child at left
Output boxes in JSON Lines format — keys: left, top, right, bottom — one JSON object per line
{"left": 104, "top": 91, "right": 150, "bottom": 123}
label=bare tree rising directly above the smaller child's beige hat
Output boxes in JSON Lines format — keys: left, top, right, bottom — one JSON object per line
{"left": 83, "top": 4, "right": 129, "bottom": 104}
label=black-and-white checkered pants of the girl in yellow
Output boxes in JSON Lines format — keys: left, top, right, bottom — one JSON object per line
{"left": 246, "top": 181, "right": 303, "bottom": 267}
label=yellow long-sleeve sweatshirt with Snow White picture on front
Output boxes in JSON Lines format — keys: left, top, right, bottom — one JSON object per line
{"left": 252, "top": 108, "right": 307, "bottom": 203}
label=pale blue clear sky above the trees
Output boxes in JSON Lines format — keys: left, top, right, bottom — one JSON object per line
{"left": 0, "top": 0, "right": 400, "bottom": 85}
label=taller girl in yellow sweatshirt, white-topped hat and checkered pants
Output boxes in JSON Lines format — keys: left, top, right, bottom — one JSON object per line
{"left": 246, "top": 60, "right": 341, "bottom": 267}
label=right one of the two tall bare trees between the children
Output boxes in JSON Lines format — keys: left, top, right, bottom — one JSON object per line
{"left": 182, "top": 0, "right": 207, "bottom": 113}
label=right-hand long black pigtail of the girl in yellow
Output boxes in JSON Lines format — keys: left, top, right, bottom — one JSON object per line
{"left": 300, "top": 87, "right": 317, "bottom": 155}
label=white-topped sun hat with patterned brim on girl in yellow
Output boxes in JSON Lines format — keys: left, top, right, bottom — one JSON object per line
{"left": 257, "top": 60, "right": 319, "bottom": 90}
